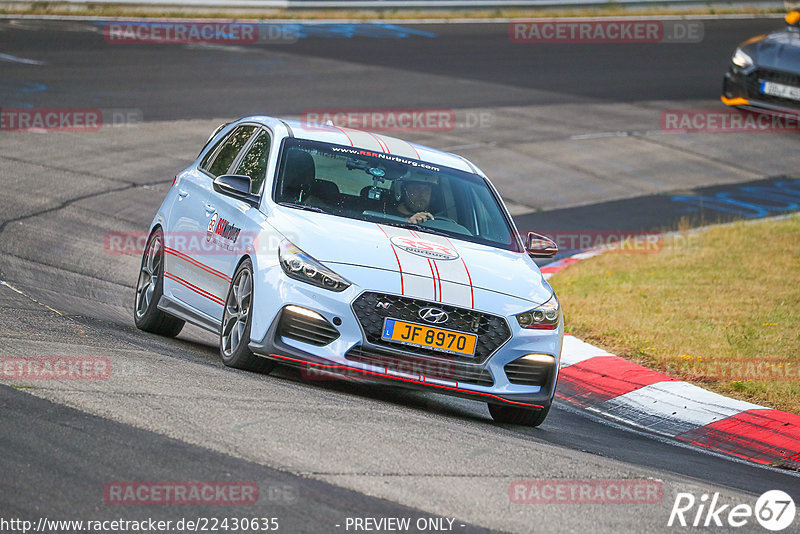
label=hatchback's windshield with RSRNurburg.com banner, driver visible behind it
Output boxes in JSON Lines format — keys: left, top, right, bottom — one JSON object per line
{"left": 273, "top": 139, "right": 519, "bottom": 251}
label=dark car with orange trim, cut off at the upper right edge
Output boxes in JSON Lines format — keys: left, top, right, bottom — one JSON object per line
{"left": 722, "top": 11, "right": 800, "bottom": 114}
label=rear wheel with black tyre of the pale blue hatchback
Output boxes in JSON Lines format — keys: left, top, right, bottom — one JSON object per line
{"left": 133, "top": 228, "right": 184, "bottom": 337}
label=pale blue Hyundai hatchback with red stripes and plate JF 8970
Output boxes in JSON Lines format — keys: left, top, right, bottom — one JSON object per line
{"left": 134, "top": 117, "right": 564, "bottom": 426}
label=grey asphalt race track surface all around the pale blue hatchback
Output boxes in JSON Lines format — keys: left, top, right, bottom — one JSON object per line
{"left": 0, "top": 19, "right": 800, "bottom": 532}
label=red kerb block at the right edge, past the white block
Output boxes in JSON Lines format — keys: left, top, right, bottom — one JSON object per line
{"left": 675, "top": 408, "right": 800, "bottom": 469}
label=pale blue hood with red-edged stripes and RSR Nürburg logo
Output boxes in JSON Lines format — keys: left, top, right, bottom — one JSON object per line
{"left": 271, "top": 207, "right": 553, "bottom": 305}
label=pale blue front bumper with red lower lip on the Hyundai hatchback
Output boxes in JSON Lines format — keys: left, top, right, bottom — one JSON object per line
{"left": 249, "top": 272, "right": 563, "bottom": 408}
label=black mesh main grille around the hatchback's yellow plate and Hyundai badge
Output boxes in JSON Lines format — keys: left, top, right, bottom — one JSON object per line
{"left": 353, "top": 292, "right": 511, "bottom": 363}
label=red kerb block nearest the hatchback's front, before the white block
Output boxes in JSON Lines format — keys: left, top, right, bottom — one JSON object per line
{"left": 556, "top": 356, "right": 676, "bottom": 407}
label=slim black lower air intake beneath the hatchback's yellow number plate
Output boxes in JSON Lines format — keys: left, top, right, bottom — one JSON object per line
{"left": 345, "top": 346, "right": 494, "bottom": 386}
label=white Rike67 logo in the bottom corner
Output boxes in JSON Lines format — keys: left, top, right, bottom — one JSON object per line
{"left": 667, "top": 490, "right": 796, "bottom": 532}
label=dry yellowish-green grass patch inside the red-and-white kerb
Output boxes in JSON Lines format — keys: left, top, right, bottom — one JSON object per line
{"left": 551, "top": 216, "right": 800, "bottom": 414}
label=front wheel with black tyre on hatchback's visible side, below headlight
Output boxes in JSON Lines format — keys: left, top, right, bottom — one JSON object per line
{"left": 219, "top": 258, "right": 275, "bottom": 373}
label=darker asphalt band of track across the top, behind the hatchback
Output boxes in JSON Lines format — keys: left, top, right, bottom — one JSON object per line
{"left": 2, "top": 19, "right": 782, "bottom": 120}
